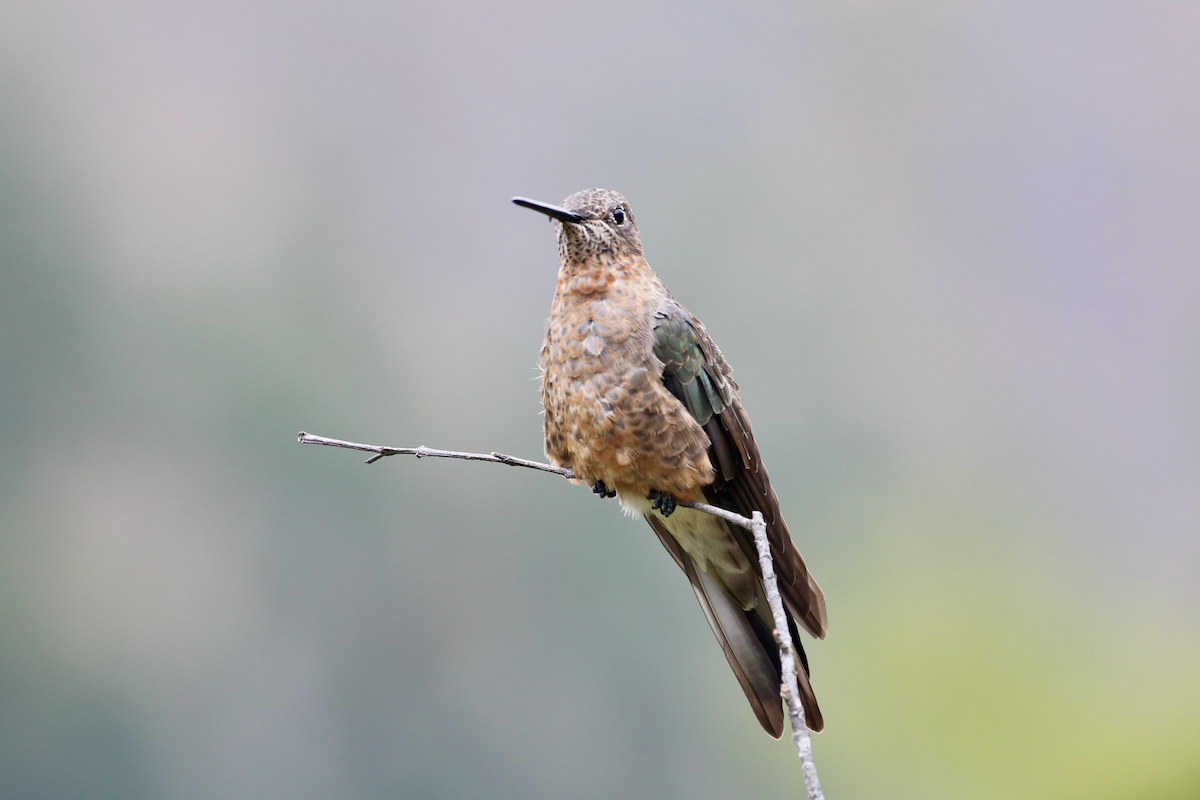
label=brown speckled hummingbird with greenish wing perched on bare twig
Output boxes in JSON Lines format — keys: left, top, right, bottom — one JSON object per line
{"left": 512, "top": 188, "right": 827, "bottom": 739}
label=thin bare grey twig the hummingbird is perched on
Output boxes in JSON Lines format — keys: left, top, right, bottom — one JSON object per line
{"left": 299, "top": 431, "right": 824, "bottom": 800}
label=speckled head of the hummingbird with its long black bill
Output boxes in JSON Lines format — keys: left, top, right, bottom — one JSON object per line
{"left": 512, "top": 188, "right": 642, "bottom": 264}
